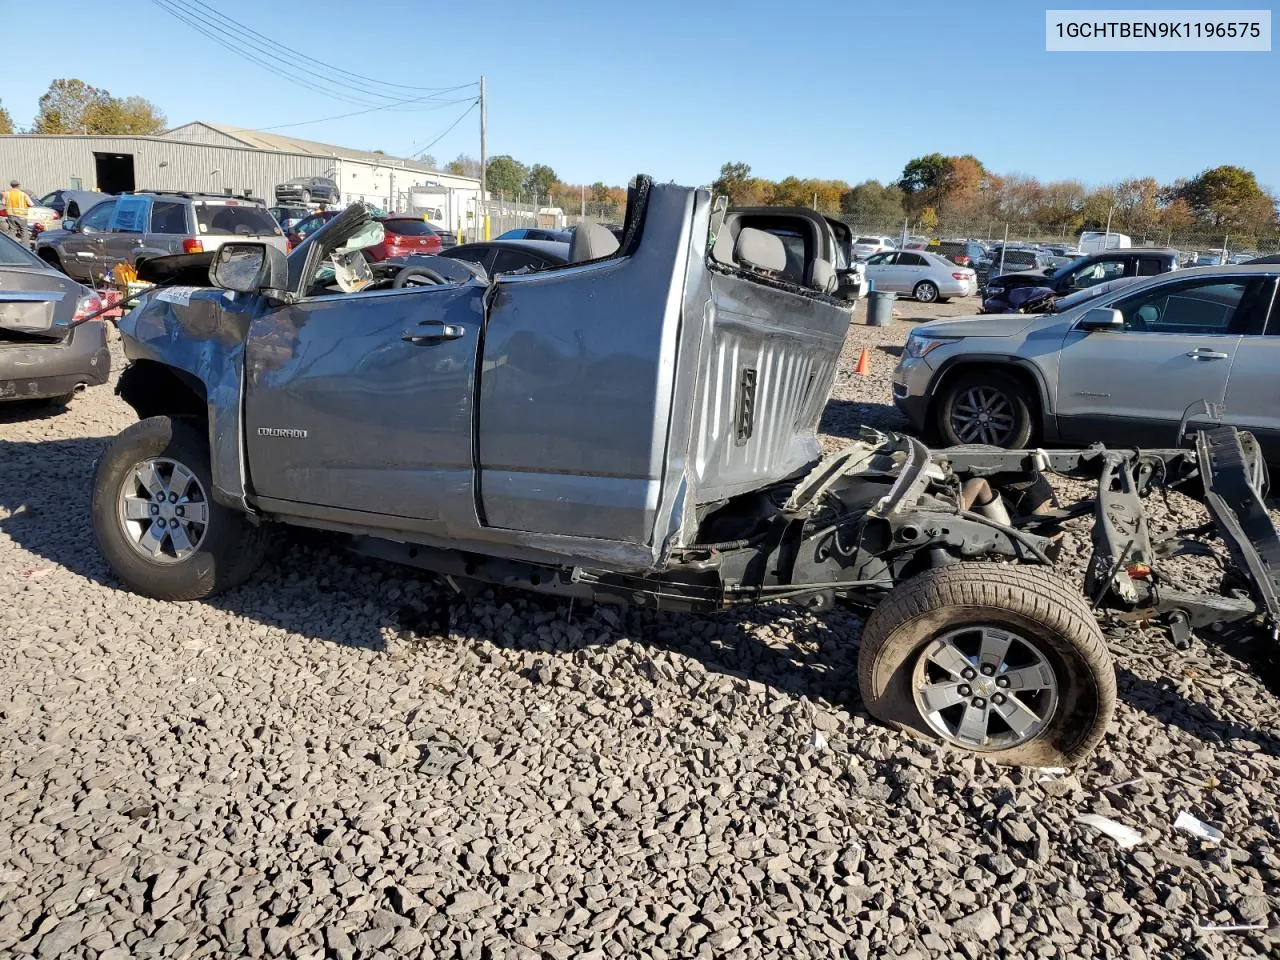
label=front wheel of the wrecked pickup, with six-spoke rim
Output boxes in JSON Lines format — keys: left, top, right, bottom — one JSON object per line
{"left": 90, "top": 416, "right": 266, "bottom": 600}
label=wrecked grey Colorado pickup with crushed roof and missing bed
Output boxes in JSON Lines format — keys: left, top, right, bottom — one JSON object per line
{"left": 92, "top": 178, "right": 1280, "bottom": 765}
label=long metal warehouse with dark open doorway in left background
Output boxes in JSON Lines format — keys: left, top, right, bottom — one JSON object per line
{"left": 0, "top": 120, "right": 480, "bottom": 227}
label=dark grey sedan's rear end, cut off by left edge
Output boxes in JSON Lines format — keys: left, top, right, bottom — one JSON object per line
{"left": 0, "top": 237, "right": 111, "bottom": 404}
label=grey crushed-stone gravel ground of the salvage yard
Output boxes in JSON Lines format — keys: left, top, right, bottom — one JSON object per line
{"left": 0, "top": 303, "right": 1280, "bottom": 960}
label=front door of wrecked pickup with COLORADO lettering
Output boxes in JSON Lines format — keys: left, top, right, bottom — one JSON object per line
{"left": 244, "top": 284, "right": 484, "bottom": 534}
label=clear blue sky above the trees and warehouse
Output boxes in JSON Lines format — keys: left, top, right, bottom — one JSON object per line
{"left": 0, "top": 0, "right": 1280, "bottom": 189}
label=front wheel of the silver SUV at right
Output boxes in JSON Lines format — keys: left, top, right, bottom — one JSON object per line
{"left": 936, "top": 370, "right": 1036, "bottom": 449}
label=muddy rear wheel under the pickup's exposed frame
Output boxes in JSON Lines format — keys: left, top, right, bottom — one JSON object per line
{"left": 858, "top": 563, "right": 1116, "bottom": 767}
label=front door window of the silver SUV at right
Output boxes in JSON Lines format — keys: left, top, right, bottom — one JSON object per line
{"left": 1115, "top": 278, "right": 1270, "bottom": 335}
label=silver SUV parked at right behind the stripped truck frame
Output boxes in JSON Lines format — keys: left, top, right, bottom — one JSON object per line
{"left": 893, "top": 265, "right": 1280, "bottom": 460}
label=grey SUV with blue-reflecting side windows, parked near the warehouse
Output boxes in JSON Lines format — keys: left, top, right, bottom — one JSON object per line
{"left": 36, "top": 193, "right": 288, "bottom": 285}
